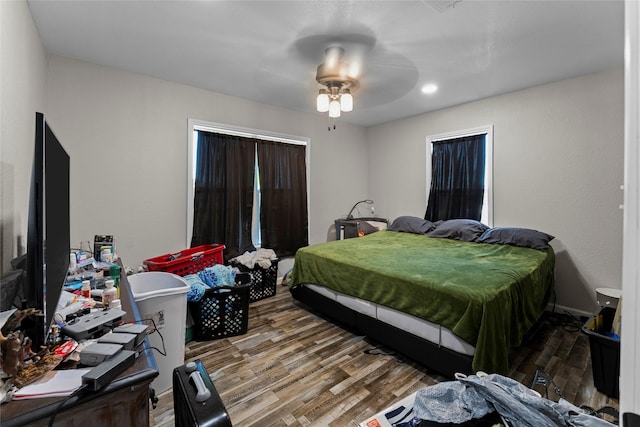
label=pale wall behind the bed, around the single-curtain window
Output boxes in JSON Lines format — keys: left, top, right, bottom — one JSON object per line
{"left": 367, "top": 69, "right": 624, "bottom": 313}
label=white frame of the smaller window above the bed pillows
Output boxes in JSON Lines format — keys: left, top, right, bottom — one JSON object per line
{"left": 426, "top": 126, "right": 493, "bottom": 227}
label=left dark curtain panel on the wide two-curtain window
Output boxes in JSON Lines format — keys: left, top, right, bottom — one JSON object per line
{"left": 191, "top": 131, "right": 256, "bottom": 259}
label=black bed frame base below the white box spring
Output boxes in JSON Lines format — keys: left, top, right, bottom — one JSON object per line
{"left": 290, "top": 285, "right": 473, "bottom": 378}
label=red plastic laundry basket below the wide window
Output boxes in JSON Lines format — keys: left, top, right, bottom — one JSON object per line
{"left": 142, "top": 243, "right": 224, "bottom": 276}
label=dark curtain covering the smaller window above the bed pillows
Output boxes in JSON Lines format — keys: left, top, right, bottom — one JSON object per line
{"left": 424, "top": 134, "right": 485, "bottom": 222}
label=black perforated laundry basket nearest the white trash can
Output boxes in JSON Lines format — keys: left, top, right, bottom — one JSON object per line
{"left": 189, "top": 273, "right": 252, "bottom": 341}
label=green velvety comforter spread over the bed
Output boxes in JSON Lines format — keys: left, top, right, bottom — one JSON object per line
{"left": 290, "top": 230, "right": 555, "bottom": 374}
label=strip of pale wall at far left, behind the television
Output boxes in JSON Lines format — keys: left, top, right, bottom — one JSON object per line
{"left": 0, "top": 1, "right": 45, "bottom": 274}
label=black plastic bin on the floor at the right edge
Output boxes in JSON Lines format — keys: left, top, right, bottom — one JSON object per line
{"left": 582, "top": 307, "right": 620, "bottom": 399}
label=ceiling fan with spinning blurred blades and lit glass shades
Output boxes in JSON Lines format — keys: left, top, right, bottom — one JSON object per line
{"left": 255, "top": 29, "right": 418, "bottom": 120}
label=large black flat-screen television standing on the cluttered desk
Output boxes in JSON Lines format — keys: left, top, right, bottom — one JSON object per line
{"left": 22, "top": 113, "right": 70, "bottom": 351}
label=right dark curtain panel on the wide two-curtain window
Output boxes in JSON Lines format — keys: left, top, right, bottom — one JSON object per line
{"left": 258, "top": 141, "right": 309, "bottom": 257}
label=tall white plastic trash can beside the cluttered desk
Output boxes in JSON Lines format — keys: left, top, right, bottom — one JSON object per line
{"left": 127, "top": 271, "right": 191, "bottom": 394}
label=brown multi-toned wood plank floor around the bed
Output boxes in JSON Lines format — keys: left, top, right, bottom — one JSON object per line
{"left": 151, "top": 286, "right": 618, "bottom": 427}
